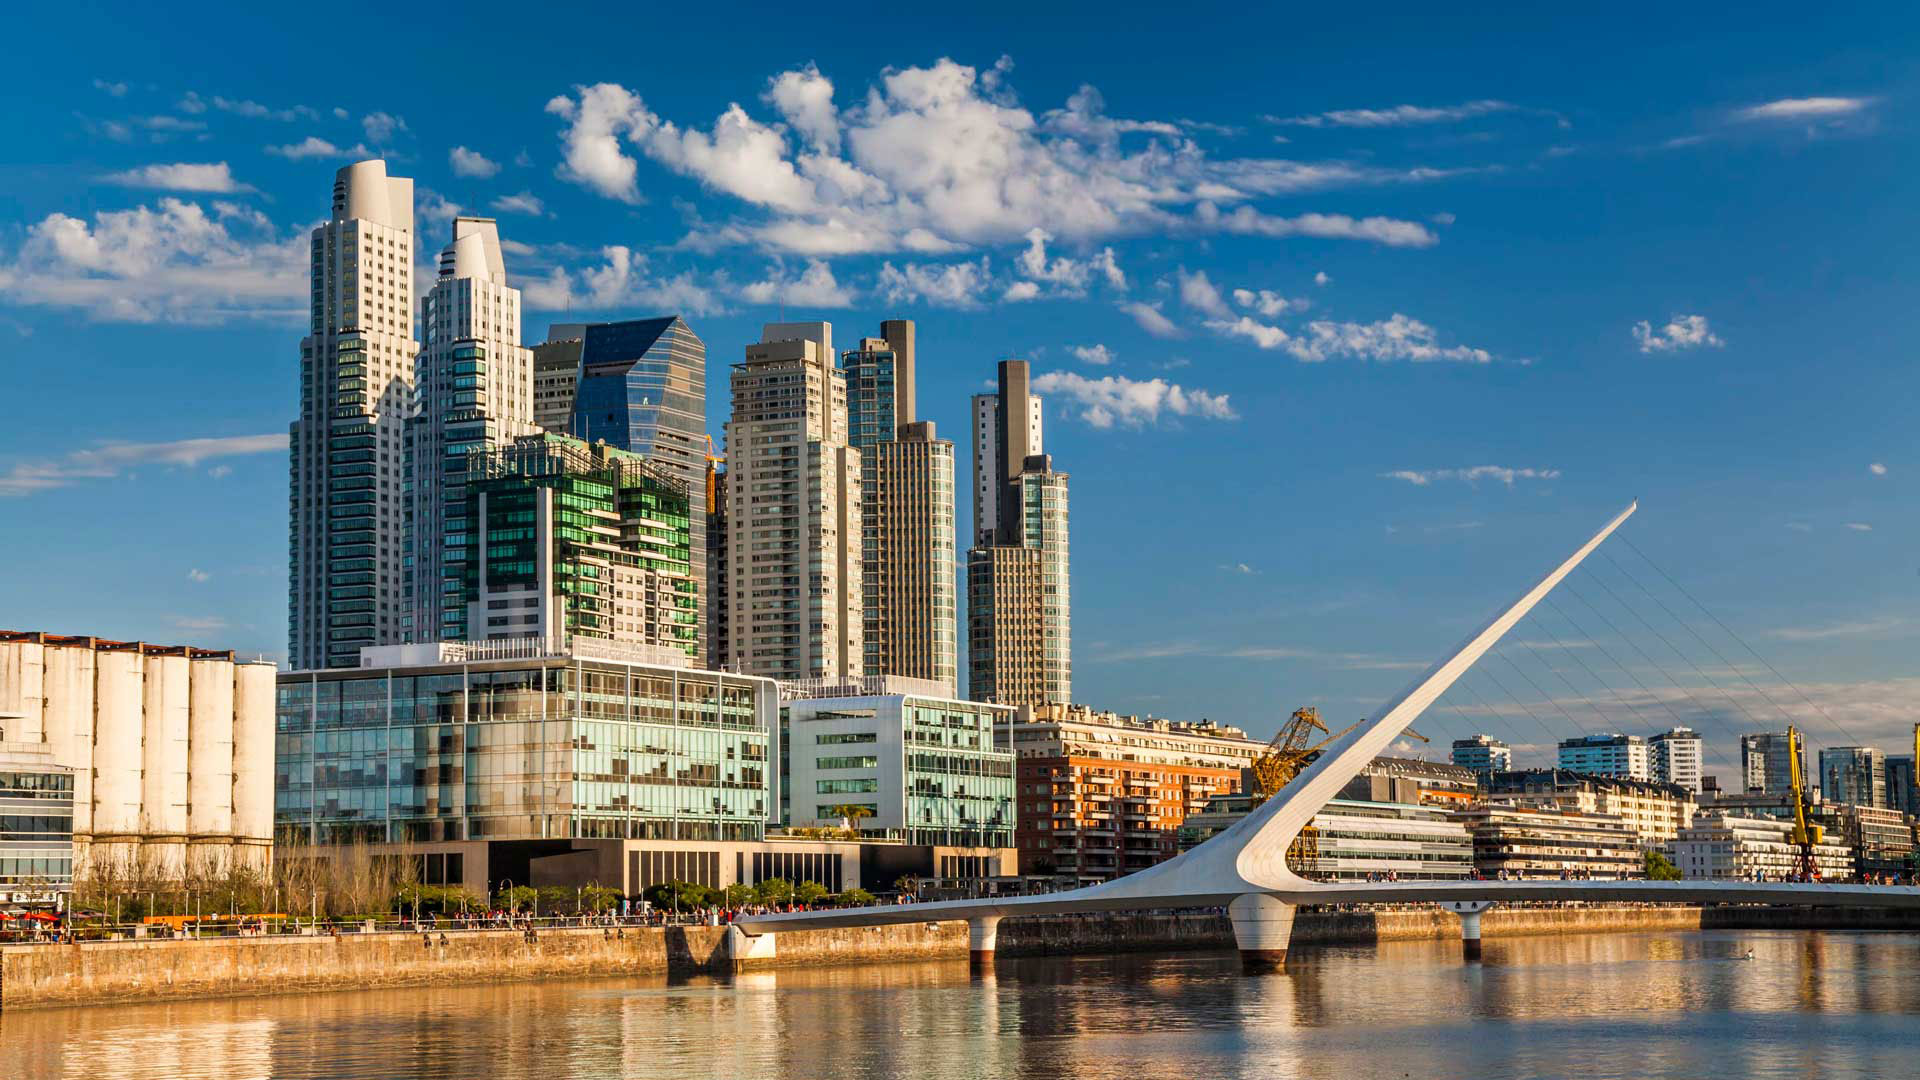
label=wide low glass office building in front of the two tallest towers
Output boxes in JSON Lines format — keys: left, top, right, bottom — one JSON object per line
{"left": 275, "top": 640, "right": 778, "bottom": 844}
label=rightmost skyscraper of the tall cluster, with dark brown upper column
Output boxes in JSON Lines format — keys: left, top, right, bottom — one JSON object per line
{"left": 968, "top": 359, "right": 1073, "bottom": 705}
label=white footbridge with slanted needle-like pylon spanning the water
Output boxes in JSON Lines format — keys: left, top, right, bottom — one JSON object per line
{"left": 732, "top": 503, "right": 1920, "bottom": 969}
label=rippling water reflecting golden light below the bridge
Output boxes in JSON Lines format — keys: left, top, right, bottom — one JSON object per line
{"left": 0, "top": 932, "right": 1920, "bottom": 1080}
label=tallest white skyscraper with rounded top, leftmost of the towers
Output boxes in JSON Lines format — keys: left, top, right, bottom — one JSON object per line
{"left": 286, "top": 160, "right": 419, "bottom": 669}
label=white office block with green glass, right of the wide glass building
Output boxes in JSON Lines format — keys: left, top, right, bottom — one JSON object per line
{"left": 781, "top": 675, "right": 1014, "bottom": 857}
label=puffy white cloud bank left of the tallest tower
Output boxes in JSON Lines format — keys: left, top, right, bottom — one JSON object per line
{"left": 0, "top": 198, "right": 307, "bottom": 323}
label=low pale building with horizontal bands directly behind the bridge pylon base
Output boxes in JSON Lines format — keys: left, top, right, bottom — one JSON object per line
{"left": 1177, "top": 794, "right": 1473, "bottom": 882}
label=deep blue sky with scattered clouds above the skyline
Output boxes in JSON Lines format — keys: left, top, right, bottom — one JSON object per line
{"left": 0, "top": 6, "right": 1920, "bottom": 773}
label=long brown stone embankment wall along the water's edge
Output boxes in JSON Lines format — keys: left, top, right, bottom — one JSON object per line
{"left": 11, "top": 907, "right": 1920, "bottom": 1009}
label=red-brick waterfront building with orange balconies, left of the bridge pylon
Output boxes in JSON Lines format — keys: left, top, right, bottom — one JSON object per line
{"left": 1006, "top": 705, "right": 1267, "bottom": 884}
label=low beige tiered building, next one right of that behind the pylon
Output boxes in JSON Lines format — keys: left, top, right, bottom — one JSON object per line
{"left": 1453, "top": 798, "right": 1645, "bottom": 880}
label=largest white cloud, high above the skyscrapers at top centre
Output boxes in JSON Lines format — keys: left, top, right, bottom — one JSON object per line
{"left": 547, "top": 60, "right": 1459, "bottom": 253}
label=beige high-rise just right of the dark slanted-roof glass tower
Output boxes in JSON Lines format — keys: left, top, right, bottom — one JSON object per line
{"left": 725, "top": 323, "right": 866, "bottom": 680}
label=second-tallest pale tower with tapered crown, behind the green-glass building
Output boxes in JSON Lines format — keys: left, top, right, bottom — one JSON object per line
{"left": 405, "top": 217, "right": 538, "bottom": 642}
